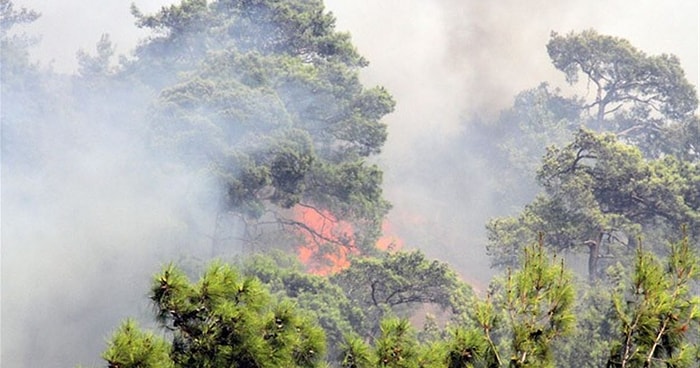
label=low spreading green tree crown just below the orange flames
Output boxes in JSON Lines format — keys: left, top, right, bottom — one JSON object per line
{"left": 243, "top": 252, "right": 472, "bottom": 364}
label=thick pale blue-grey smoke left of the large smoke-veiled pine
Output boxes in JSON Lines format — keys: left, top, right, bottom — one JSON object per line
{"left": 1, "top": 2, "right": 215, "bottom": 367}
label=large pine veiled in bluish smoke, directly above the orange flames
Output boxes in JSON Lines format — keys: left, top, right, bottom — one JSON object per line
{"left": 127, "top": 0, "right": 394, "bottom": 258}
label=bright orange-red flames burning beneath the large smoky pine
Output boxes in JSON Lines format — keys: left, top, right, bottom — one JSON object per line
{"left": 294, "top": 206, "right": 403, "bottom": 275}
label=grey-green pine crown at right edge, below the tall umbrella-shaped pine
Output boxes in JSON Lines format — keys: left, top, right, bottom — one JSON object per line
{"left": 487, "top": 130, "right": 700, "bottom": 279}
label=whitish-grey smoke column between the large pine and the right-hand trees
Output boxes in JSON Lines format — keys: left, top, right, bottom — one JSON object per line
{"left": 326, "top": 0, "right": 700, "bottom": 284}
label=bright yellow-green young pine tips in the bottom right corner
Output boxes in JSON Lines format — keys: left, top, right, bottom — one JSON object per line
{"left": 608, "top": 234, "right": 700, "bottom": 367}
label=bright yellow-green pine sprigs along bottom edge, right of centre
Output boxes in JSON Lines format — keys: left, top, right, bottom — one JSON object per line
{"left": 330, "top": 245, "right": 574, "bottom": 367}
